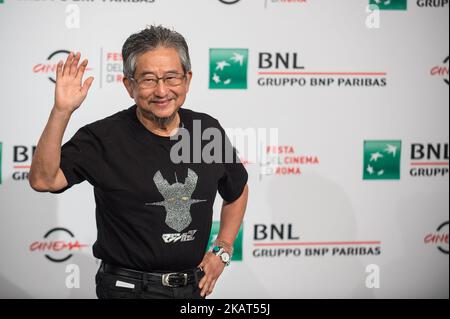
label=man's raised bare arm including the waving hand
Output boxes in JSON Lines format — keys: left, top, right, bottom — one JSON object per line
{"left": 29, "top": 53, "right": 94, "bottom": 192}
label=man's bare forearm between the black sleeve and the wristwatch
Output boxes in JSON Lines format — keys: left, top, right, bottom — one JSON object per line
{"left": 217, "top": 185, "right": 248, "bottom": 247}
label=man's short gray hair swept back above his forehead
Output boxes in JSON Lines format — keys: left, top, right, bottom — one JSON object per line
{"left": 122, "top": 25, "right": 191, "bottom": 78}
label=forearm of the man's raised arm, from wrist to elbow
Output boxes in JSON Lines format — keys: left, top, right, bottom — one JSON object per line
{"left": 29, "top": 108, "right": 71, "bottom": 187}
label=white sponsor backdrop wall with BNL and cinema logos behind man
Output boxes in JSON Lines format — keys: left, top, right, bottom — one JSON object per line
{"left": 0, "top": 0, "right": 449, "bottom": 298}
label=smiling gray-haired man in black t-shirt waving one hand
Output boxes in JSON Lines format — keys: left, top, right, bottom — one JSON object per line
{"left": 29, "top": 26, "right": 248, "bottom": 298}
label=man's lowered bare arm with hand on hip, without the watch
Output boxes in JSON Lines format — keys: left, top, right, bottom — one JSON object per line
{"left": 199, "top": 185, "right": 248, "bottom": 296}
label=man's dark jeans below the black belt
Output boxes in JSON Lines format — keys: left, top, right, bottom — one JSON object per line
{"left": 95, "top": 266, "right": 204, "bottom": 299}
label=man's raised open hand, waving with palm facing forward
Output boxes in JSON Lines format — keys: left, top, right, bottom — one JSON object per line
{"left": 54, "top": 52, "right": 94, "bottom": 113}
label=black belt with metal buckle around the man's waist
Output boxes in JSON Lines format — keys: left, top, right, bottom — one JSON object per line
{"left": 102, "top": 263, "right": 204, "bottom": 287}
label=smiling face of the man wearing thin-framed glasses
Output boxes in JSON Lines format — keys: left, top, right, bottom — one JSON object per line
{"left": 124, "top": 47, "right": 192, "bottom": 122}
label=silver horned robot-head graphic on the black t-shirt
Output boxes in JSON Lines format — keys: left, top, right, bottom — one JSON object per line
{"left": 145, "top": 168, "right": 206, "bottom": 232}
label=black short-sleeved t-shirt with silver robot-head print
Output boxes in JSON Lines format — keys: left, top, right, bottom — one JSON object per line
{"left": 55, "top": 105, "right": 248, "bottom": 271}
